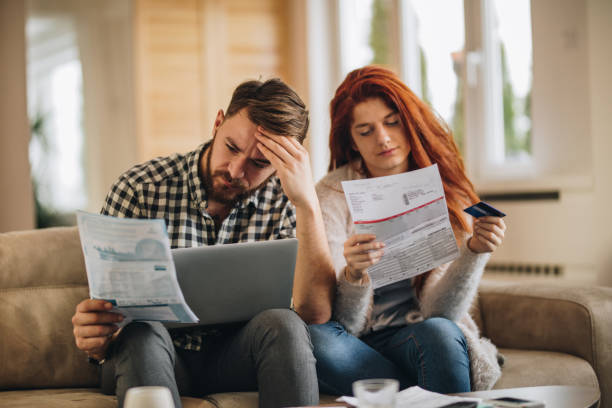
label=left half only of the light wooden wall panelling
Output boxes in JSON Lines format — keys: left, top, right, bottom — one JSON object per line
{"left": 134, "top": 0, "right": 203, "bottom": 161}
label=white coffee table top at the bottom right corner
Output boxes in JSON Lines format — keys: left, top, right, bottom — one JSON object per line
{"left": 453, "top": 385, "right": 600, "bottom": 408}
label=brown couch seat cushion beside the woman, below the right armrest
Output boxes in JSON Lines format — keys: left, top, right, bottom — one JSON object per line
{"left": 493, "top": 348, "right": 599, "bottom": 389}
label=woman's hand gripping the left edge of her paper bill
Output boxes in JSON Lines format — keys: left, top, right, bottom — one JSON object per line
{"left": 344, "top": 234, "right": 385, "bottom": 283}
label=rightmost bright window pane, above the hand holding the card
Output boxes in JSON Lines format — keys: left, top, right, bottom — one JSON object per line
{"left": 476, "top": 0, "right": 533, "bottom": 178}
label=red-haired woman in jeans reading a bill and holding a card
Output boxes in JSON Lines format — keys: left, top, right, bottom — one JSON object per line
{"left": 310, "top": 66, "right": 506, "bottom": 395}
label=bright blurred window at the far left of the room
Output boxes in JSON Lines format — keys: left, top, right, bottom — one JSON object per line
{"left": 27, "top": 17, "right": 87, "bottom": 227}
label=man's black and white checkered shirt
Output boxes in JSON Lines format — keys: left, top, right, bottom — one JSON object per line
{"left": 101, "top": 142, "right": 296, "bottom": 351}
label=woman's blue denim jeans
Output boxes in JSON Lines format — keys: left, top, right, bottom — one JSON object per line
{"left": 309, "top": 317, "right": 470, "bottom": 395}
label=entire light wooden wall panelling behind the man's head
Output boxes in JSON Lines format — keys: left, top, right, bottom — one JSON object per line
{"left": 134, "top": 0, "right": 306, "bottom": 160}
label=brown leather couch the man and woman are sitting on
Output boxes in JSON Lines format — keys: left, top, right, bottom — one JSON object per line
{"left": 0, "top": 228, "right": 612, "bottom": 407}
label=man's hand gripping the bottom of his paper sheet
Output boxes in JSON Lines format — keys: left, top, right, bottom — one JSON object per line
{"left": 72, "top": 299, "right": 123, "bottom": 360}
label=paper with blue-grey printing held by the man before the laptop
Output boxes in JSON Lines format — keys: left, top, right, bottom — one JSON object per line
{"left": 77, "top": 211, "right": 198, "bottom": 323}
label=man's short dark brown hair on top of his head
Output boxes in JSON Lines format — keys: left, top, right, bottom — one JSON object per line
{"left": 225, "top": 78, "right": 309, "bottom": 143}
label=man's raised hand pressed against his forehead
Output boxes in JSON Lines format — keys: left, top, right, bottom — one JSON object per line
{"left": 255, "top": 126, "right": 317, "bottom": 209}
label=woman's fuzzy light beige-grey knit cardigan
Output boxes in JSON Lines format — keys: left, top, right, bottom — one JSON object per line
{"left": 316, "top": 160, "right": 502, "bottom": 391}
